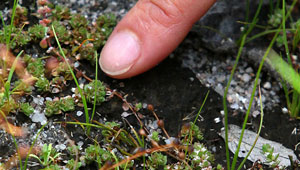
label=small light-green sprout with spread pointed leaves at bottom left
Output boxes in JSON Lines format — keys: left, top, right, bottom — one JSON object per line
{"left": 29, "top": 143, "right": 61, "bottom": 168}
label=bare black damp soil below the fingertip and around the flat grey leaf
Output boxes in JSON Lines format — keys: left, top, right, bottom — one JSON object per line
{"left": 75, "top": 58, "right": 300, "bottom": 168}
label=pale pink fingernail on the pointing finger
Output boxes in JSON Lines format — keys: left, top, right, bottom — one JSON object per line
{"left": 99, "top": 31, "right": 140, "bottom": 76}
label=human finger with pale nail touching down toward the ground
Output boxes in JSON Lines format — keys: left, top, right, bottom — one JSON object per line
{"left": 99, "top": 0, "right": 215, "bottom": 79}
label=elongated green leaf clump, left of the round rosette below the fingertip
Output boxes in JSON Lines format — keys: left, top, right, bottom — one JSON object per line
{"left": 45, "top": 97, "right": 75, "bottom": 117}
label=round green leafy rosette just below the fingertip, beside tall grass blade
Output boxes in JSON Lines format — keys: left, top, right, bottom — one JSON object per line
{"left": 83, "top": 80, "right": 106, "bottom": 104}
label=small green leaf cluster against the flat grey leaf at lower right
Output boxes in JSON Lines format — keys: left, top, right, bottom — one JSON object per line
{"left": 262, "top": 144, "right": 280, "bottom": 168}
